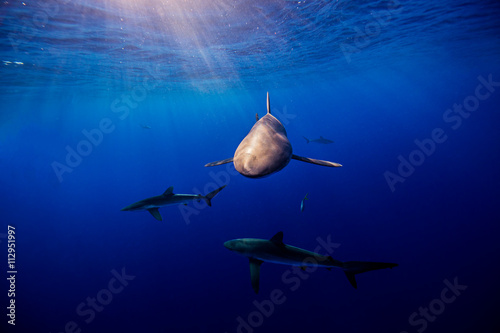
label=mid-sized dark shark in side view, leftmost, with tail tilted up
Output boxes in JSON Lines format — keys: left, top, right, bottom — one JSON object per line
{"left": 122, "top": 185, "right": 226, "bottom": 221}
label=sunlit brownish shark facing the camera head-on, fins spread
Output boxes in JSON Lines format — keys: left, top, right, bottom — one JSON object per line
{"left": 205, "top": 93, "right": 342, "bottom": 178}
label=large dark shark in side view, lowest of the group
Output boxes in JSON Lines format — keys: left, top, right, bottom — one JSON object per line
{"left": 224, "top": 231, "right": 398, "bottom": 294}
